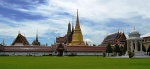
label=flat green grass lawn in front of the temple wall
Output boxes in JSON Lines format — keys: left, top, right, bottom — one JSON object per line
{"left": 0, "top": 56, "right": 150, "bottom": 69}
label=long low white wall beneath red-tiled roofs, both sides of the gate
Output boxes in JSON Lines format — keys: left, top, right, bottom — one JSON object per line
{"left": 0, "top": 52, "right": 103, "bottom": 56}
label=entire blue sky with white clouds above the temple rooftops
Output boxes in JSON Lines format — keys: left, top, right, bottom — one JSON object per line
{"left": 0, "top": 0, "right": 150, "bottom": 45}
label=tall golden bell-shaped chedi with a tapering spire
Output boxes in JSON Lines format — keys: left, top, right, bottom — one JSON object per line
{"left": 69, "top": 9, "right": 85, "bottom": 46}
